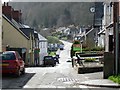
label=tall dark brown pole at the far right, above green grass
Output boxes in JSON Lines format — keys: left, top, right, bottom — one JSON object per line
{"left": 113, "top": 1, "right": 120, "bottom": 75}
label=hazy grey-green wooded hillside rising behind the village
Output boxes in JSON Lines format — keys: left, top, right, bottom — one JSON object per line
{"left": 10, "top": 2, "right": 94, "bottom": 28}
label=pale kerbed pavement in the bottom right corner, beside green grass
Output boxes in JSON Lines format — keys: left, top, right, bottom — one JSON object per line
{"left": 80, "top": 79, "right": 120, "bottom": 88}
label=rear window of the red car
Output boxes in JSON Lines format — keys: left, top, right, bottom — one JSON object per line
{"left": 0, "top": 52, "right": 16, "bottom": 60}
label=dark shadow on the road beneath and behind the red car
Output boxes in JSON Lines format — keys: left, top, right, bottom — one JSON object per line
{"left": 2, "top": 73, "right": 35, "bottom": 89}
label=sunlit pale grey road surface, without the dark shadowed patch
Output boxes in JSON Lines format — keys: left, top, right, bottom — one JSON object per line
{"left": 24, "top": 42, "right": 102, "bottom": 88}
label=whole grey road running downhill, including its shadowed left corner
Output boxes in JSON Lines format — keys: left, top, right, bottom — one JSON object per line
{"left": 2, "top": 41, "right": 117, "bottom": 90}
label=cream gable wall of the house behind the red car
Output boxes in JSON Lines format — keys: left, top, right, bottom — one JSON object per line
{"left": 2, "top": 18, "right": 30, "bottom": 63}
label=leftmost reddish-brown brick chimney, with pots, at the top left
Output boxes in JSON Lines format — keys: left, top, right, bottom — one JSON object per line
{"left": 2, "top": 2, "right": 12, "bottom": 20}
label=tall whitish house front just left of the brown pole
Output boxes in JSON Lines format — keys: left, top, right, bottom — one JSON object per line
{"left": 98, "top": 1, "right": 113, "bottom": 52}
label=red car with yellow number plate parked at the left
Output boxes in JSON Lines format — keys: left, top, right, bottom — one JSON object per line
{"left": 0, "top": 51, "right": 25, "bottom": 76}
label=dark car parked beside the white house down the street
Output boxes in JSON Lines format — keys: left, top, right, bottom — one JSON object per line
{"left": 43, "top": 56, "right": 56, "bottom": 67}
